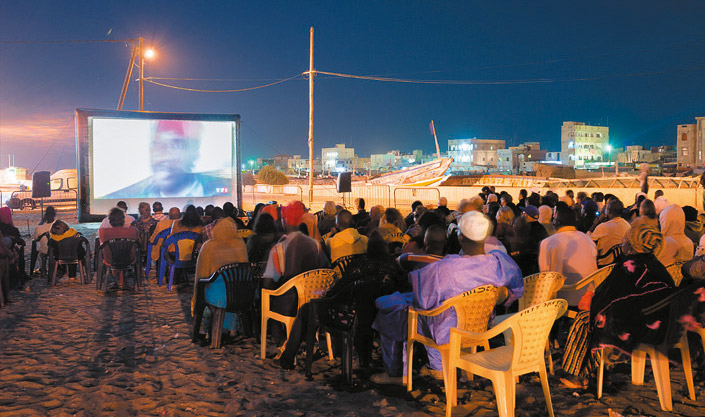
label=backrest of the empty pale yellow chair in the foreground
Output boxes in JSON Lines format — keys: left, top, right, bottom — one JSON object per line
{"left": 507, "top": 299, "right": 568, "bottom": 374}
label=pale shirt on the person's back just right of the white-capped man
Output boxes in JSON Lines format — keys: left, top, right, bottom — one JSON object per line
{"left": 539, "top": 227, "right": 597, "bottom": 306}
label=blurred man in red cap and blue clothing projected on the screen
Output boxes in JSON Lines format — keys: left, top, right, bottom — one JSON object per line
{"left": 103, "top": 120, "right": 230, "bottom": 198}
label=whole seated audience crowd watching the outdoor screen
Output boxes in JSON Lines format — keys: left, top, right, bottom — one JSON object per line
{"left": 0, "top": 187, "right": 705, "bottom": 410}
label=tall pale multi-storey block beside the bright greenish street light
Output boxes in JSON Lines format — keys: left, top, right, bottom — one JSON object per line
{"left": 561, "top": 122, "right": 611, "bottom": 168}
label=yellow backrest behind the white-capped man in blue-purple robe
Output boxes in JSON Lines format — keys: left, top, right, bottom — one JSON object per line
{"left": 443, "top": 285, "right": 500, "bottom": 333}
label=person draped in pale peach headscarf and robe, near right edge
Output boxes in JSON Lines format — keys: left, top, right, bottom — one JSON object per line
{"left": 658, "top": 204, "right": 694, "bottom": 265}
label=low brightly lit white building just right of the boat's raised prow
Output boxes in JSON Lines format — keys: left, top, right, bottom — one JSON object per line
{"left": 448, "top": 138, "right": 505, "bottom": 172}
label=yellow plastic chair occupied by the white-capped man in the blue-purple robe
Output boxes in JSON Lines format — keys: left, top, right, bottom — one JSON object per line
{"left": 406, "top": 285, "right": 503, "bottom": 391}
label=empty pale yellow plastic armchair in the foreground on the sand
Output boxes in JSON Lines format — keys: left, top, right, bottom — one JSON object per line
{"left": 446, "top": 299, "right": 568, "bottom": 417}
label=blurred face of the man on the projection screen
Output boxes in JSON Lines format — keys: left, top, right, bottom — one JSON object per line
{"left": 149, "top": 122, "right": 201, "bottom": 187}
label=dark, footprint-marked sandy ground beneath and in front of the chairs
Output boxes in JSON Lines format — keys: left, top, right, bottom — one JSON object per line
{"left": 0, "top": 212, "right": 705, "bottom": 417}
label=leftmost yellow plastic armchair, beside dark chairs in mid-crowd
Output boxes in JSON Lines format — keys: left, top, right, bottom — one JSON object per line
{"left": 260, "top": 269, "right": 338, "bottom": 360}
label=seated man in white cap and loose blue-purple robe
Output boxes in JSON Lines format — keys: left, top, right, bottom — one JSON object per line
{"left": 372, "top": 211, "right": 524, "bottom": 383}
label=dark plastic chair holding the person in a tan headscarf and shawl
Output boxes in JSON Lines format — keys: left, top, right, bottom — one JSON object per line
{"left": 192, "top": 262, "right": 261, "bottom": 349}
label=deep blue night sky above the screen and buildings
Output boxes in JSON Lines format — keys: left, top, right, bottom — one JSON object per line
{"left": 0, "top": 0, "right": 705, "bottom": 171}
